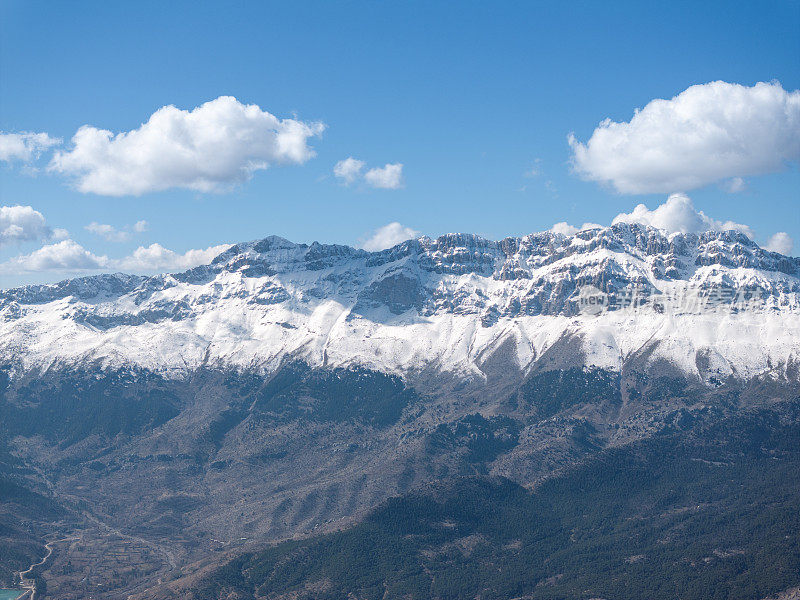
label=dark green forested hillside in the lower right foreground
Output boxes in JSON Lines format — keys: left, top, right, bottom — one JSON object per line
{"left": 194, "top": 402, "right": 800, "bottom": 600}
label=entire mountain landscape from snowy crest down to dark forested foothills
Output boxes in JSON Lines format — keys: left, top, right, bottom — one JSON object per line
{"left": 0, "top": 225, "right": 800, "bottom": 598}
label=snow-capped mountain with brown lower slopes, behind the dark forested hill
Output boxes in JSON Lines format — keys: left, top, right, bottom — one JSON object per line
{"left": 0, "top": 225, "right": 800, "bottom": 600}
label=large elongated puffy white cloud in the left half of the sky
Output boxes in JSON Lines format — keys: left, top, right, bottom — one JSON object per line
{"left": 49, "top": 96, "right": 325, "bottom": 196}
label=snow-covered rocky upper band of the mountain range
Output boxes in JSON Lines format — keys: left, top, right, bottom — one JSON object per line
{"left": 0, "top": 224, "right": 800, "bottom": 382}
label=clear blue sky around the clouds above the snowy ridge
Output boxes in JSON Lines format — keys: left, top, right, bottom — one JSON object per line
{"left": 0, "top": 0, "right": 800, "bottom": 287}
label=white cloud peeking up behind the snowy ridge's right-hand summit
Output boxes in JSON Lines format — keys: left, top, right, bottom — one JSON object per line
{"left": 612, "top": 194, "right": 753, "bottom": 238}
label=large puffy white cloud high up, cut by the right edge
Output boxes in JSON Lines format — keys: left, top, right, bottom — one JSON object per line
{"left": 569, "top": 81, "right": 800, "bottom": 194}
